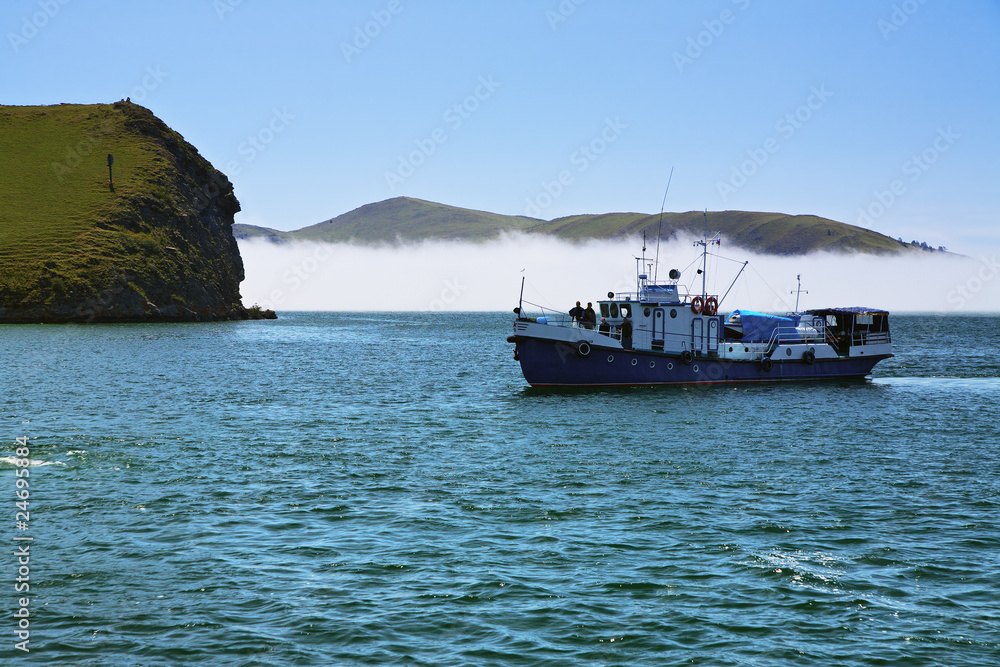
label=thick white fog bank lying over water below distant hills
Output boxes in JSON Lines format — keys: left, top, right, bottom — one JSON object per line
{"left": 239, "top": 235, "right": 1000, "bottom": 313}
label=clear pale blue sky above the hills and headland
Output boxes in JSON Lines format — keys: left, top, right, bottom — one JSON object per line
{"left": 7, "top": 0, "right": 1000, "bottom": 253}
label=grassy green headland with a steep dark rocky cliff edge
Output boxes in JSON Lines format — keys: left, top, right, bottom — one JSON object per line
{"left": 0, "top": 101, "right": 274, "bottom": 322}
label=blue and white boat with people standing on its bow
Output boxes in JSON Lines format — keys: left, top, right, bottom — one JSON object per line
{"left": 507, "top": 228, "right": 893, "bottom": 387}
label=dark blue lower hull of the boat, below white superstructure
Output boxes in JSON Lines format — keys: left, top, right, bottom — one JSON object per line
{"left": 517, "top": 338, "right": 892, "bottom": 387}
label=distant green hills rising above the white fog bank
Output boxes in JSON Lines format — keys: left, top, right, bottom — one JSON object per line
{"left": 233, "top": 197, "right": 913, "bottom": 255}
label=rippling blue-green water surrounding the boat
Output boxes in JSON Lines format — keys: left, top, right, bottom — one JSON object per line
{"left": 0, "top": 313, "right": 1000, "bottom": 666}
